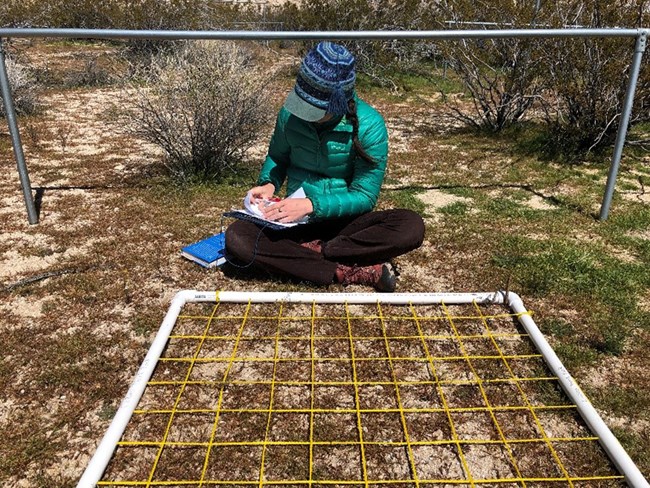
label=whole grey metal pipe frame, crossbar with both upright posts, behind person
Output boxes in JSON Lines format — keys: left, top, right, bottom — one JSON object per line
{"left": 0, "top": 28, "right": 650, "bottom": 224}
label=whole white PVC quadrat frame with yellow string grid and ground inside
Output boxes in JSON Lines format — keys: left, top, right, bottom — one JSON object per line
{"left": 77, "top": 290, "right": 650, "bottom": 488}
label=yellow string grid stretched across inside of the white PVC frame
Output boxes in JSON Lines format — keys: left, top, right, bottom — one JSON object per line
{"left": 98, "top": 300, "right": 623, "bottom": 488}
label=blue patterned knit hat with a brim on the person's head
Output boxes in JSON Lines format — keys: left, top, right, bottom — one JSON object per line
{"left": 284, "top": 41, "right": 356, "bottom": 122}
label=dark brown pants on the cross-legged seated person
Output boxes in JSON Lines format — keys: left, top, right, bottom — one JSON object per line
{"left": 226, "top": 209, "right": 424, "bottom": 285}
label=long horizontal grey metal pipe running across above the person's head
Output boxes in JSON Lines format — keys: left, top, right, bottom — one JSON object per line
{"left": 0, "top": 28, "right": 647, "bottom": 40}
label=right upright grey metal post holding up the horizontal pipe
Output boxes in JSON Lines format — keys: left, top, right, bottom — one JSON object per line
{"left": 599, "top": 29, "right": 648, "bottom": 220}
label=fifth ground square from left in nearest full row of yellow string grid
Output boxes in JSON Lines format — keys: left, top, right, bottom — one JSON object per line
{"left": 312, "top": 445, "right": 363, "bottom": 481}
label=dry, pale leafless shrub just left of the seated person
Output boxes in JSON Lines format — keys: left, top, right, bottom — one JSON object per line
{"left": 129, "top": 42, "right": 271, "bottom": 180}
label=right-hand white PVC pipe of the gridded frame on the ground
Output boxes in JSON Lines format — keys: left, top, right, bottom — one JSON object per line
{"left": 506, "top": 293, "right": 650, "bottom": 488}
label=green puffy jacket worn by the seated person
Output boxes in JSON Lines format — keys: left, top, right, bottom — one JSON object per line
{"left": 258, "top": 99, "right": 388, "bottom": 220}
